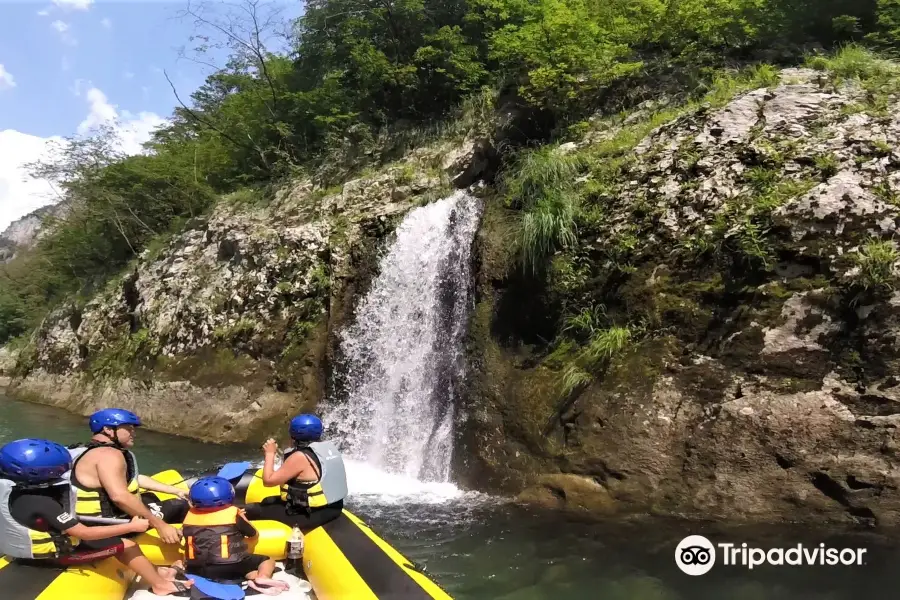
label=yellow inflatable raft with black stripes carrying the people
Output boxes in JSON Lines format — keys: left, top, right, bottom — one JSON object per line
{"left": 0, "top": 469, "right": 452, "bottom": 600}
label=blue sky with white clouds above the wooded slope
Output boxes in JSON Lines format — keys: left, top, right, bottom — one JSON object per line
{"left": 0, "top": 0, "right": 301, "bottom": 232}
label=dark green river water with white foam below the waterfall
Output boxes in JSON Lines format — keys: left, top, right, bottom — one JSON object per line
{"left": 0, "top": 397, "right": 900, "bottom": 600}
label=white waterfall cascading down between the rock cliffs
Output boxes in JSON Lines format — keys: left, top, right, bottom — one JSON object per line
{"left": 323, "top": 191, "right": 481, "bottom": 493}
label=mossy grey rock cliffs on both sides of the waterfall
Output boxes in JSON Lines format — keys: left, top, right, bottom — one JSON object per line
{"left": 14, "top": 63, "right": 900, "bottom": 525}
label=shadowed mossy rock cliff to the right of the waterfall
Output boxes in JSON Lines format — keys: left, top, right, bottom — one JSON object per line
{"left": 457, "top": 69, "right": 900, "bottom": 525}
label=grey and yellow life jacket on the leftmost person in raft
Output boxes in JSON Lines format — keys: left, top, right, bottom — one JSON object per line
{"left": 0, "top": 479, "right": 78, "bottom": 559}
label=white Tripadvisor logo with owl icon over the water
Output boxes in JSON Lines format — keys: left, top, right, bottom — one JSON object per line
{"left": 675, "top": 535, "right": 867, "bottom": 575}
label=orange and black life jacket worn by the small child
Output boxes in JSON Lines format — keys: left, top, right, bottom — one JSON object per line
{"left": 181, "top": 505, "right": 250, "bottom": 565}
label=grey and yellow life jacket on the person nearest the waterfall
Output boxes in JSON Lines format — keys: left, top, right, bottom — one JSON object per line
{"left": 281, "top": 442, "right": 347, "bottom": 510}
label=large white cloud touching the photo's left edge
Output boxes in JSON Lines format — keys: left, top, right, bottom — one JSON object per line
{"left": 0, "top": 129, "right": 62, "bottom": 232}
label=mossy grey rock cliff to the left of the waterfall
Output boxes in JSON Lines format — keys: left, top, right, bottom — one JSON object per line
{"left": 7, "top": 140, "right": 486, "bottom": 441}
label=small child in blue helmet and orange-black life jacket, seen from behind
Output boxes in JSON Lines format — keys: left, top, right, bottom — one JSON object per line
{"left": 173, "top": 477, "right": 290, "bottom": 596}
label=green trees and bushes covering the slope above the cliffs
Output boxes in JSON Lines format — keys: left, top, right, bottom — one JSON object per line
{"left": 0, "top": 0, "right": 900, "bottom": 342}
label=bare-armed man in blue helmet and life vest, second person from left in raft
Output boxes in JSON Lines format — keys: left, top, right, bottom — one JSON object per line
{"left": 69, "top": 408, "right": 190, "bottom": 544}
